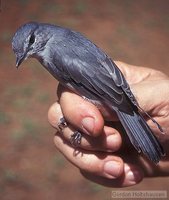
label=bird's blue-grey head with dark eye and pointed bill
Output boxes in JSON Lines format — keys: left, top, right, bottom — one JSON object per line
{"left": 12, "top": 22, "right": 48, "bottom": 68}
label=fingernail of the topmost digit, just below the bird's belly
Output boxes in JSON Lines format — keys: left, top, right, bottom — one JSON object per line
{"left": 82, "top": 117, "right": 95, "bottom": 134}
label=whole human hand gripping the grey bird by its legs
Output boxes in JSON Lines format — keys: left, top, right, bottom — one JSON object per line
{"left": 48, "top": 62, "right": 169, "bottom": 187}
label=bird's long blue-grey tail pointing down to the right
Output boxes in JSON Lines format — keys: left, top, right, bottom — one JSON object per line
{"left": 117, "top": 110, "right": 165, "bottom": 163}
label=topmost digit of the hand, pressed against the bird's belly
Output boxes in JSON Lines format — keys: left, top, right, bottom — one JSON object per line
{"left": 58, "top": 83, "right": 117, "bottom": 136}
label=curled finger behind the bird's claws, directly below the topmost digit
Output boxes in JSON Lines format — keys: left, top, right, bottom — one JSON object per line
{"left": 48, "top": 102, "right": 122, "bottom": 152}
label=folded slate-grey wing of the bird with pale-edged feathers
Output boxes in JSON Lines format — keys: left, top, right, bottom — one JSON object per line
{"left": 53, "top": 32, "right": 137, "bottom": 112}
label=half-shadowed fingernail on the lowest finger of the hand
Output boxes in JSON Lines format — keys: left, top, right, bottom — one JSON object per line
{"left": 126, "top": 170, "right": 143, "bottom": 184}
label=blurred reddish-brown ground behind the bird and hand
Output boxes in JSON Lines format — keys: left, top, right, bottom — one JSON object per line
{"left": 0, "top": 0, "right": 169, "bottom": 200}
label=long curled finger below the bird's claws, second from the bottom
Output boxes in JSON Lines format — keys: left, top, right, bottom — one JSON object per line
{"left": 54, "top": 133, "right": 123, "bottom": 179}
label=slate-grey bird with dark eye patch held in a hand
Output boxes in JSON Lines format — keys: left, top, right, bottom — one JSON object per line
{"left": 12, "top": 22, "right": 165, "bottom": 164}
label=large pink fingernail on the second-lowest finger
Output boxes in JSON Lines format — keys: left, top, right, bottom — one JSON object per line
{"left": 104, "top": 161, "right": 121, "bottom": 179}
